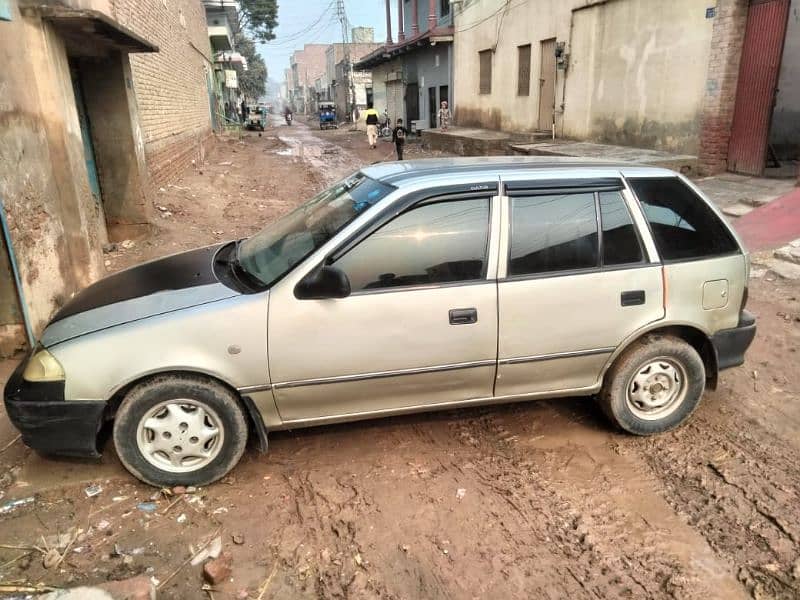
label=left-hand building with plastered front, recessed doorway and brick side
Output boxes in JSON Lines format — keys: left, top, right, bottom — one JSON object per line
{"left": 0, "top": 0, "right": 216, "bottom": 354}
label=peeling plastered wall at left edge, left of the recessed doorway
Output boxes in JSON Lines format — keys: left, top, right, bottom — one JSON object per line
{"left": 0, "top": 0, "right": 106, "bottom": 346}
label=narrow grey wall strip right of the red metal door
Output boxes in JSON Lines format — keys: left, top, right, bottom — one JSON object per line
{"left": 770, "top": 0, "right": 800, "bottom": 159}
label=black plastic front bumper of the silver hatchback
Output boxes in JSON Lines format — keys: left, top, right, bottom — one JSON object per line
{"left": 4, "top": 359, "right": 106, "bottom": 457}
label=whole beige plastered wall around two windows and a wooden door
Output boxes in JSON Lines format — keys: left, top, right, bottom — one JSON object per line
{"left": 454, "top": 0, "right": 713, "bottom": 153}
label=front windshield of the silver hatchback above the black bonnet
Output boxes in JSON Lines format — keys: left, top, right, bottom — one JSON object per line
{"left": 238, "top": 173, "right": 395, "bottom": 287}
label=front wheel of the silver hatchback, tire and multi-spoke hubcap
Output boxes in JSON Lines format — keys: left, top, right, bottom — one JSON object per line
{"left": 113, "top": 375, "right": 247, "bottom": 487}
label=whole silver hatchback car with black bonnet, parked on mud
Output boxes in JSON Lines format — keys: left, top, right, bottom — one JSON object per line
{"left": 5, "top": 158, "right": 755, "bottom": 486}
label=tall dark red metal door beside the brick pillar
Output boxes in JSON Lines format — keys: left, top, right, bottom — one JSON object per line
{"left": 728, "top": 0, "right": 789, "bottom": 175}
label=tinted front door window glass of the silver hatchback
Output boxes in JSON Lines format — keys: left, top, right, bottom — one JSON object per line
{"left": 336, "top": 198, "right": 489, "bottom": 292}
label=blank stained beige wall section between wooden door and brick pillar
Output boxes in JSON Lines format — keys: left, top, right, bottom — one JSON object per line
{"left": 562, "top": 0, "right": 714, "bottom": 154}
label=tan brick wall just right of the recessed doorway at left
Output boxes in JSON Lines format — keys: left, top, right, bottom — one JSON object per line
{"left": 113, "top": 0, "right": 212, "bottom": 186}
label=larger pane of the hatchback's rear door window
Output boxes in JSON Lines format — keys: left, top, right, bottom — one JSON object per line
{"left": 508, "top": 193, "right": 598, "bottom": 276}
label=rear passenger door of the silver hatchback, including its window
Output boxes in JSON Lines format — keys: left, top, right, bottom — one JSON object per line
{"left": 495, "top": 179, "right": 664, "bottom": 396}
